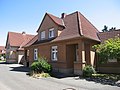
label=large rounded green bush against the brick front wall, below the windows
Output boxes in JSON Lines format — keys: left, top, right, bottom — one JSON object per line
{"left": 30, "top": 58, "right": 52, "bottom": 73}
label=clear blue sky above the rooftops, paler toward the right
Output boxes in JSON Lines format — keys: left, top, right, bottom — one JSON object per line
{"left": 0, "top": 0, "right": 120, "bottom": 46}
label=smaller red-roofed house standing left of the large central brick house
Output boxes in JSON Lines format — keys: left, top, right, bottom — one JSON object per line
{"left": 5, "top": 32, "right": 34, "bottom": 63}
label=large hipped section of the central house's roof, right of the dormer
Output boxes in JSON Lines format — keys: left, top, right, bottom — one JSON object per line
{"left": 54, "top": 11, "right": 100, "bottom": 41}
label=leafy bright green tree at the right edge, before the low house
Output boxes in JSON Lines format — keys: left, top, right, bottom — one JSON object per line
{"left": 93, "top": 37, "right": 120, "bottom": 62}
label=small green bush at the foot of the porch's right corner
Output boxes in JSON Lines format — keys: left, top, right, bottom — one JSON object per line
{"left": 83, "top": 65, "right": 96, "bottom": 77}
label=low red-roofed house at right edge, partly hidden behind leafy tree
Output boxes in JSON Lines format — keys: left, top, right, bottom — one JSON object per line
{"left": 97, "top": 29, "right": 120, "bottom": 73}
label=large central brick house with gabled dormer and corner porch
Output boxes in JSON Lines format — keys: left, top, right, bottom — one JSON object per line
{"left": 24, "top": 11, "right": 100, "bottom": 74}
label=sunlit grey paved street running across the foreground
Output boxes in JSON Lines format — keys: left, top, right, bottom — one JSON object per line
{"left": 0, "top": 64, "right": 120, "bottom": 90}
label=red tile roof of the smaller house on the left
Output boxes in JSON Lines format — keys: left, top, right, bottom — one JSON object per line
{"left": 6, "top": 32, "right": 34, "bottom": 48}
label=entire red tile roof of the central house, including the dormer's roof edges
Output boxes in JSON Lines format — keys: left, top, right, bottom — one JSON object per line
{"left": 26, "top": 11, "right": 100, "bottom": 46}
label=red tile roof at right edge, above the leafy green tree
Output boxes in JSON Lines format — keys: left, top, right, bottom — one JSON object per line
{"left": 98, "top": 29, "right": 120, "bottom": 42}
